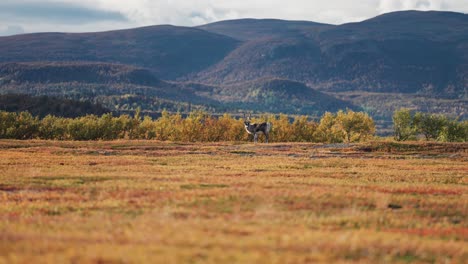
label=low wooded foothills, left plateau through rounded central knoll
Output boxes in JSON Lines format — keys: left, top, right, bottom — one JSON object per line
{"left": 0, "top": 62, "right": 355, "bottom": 114}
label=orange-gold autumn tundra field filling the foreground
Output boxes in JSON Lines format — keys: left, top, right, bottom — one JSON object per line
{"left": 0, "top": 140, "right": 468, "bottom": 263}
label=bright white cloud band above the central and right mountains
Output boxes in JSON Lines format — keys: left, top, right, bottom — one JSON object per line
{"left": 92, "top": 0, "right": 468, "bottom": 26}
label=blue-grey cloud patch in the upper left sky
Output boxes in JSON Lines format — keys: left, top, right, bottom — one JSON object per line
{"left": 0, "top": 0, "right": 127, "bottom": 24}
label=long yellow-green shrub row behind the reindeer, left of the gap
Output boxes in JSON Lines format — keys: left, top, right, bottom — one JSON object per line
{"left": 0, "top": 110, "right": 375, "bottom": 143}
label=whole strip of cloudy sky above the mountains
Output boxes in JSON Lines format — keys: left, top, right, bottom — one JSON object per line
{"left": 0, "top": 0, "right": 468, "bottom": 35}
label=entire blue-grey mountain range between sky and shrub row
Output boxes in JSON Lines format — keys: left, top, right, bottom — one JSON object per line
{"left": 0, "top": 11, "right": 468, "bottom": 119}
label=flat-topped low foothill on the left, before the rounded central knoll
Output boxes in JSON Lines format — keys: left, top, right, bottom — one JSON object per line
{"left": 0, "top": 62, "right": 224, "bottom": 111}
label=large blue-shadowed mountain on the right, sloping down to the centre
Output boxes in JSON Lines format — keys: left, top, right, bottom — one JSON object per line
{"left": 196, "top": 11, "right": 468, "bottom": 97}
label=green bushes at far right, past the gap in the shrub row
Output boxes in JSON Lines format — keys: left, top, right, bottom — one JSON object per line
{"left": 393, "top": 109, "right": 468, "bottom": 142}
